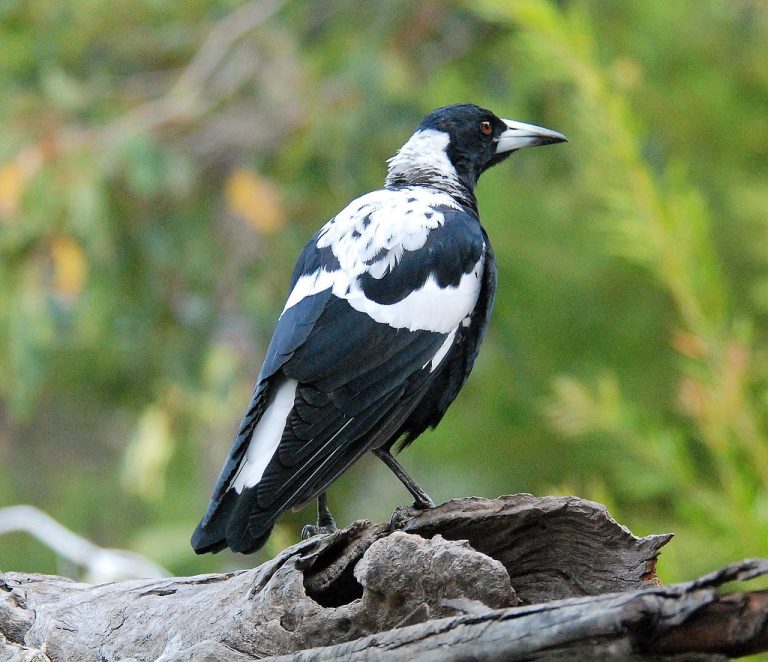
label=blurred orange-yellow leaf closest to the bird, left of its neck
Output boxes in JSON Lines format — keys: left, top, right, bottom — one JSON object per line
{"left": 224, "top": 168, "right": 285, "bottom": 234}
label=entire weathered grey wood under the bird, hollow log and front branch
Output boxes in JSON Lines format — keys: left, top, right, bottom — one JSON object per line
{"left": 0, "top": 494, "right": 768, "bottom": 662}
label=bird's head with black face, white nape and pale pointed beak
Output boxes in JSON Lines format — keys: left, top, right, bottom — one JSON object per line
{"left": 387, "top": 104, "right": 567, "bottom": 209}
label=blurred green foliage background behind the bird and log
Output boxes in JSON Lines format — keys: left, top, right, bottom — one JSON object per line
{"left": 0, "top": 0, "right": 768, "bottom": 581}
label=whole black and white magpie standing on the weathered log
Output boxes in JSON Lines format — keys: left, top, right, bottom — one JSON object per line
{"left": 192, "top": 104, "right": 566, "bottom": 554}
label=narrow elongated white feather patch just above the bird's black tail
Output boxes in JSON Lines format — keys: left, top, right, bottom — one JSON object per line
{"left": 231, "top": 379, "right": 298, "bottom": 493}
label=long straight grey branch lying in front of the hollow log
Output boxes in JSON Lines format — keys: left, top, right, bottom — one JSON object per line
{"left": 268, "top": 560, "right": 768, "bottom": 662}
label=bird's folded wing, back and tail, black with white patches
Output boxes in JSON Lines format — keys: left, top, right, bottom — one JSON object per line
{"left": 193, "top": 193, "right": 485, "bottom": 551}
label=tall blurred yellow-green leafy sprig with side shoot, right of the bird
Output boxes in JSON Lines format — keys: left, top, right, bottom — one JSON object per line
{"left": 484, "top": 0, "right": 768, "bottom": 580}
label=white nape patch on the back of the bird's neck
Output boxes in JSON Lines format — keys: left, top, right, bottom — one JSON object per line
{"left": 387, "top": 129, "right": 459, "bottom": 186}
